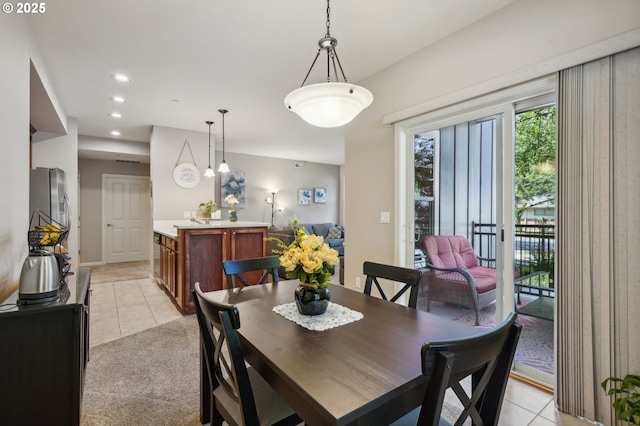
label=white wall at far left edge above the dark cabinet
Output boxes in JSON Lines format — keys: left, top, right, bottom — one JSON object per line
{"left": 0, "top": 14, "right": 30, "bottom": 302}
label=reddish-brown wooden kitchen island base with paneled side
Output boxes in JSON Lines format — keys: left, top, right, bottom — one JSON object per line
{"left": 167, "top": 226, "right": 267, "bottom": 314}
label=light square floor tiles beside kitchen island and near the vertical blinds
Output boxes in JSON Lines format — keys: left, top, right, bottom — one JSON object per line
{"left": 90, "top": 272, "right": 591, "bottom": 426}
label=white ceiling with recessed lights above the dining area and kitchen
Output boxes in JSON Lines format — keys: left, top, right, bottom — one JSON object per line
{"left": 28, "top": 0, "right": 513, "bottom": 164}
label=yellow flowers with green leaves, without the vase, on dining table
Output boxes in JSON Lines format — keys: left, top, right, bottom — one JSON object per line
{"left": 273, "top": 220, "right": 338, "bottom": 288}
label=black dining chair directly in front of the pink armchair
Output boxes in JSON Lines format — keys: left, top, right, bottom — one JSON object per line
{"left": 362, "top": 262, "right": 422, "bottom": 309}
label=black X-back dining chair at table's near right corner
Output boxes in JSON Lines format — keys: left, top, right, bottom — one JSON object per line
{"left": 392, "top": 312, "right": 522, "bottom": 426}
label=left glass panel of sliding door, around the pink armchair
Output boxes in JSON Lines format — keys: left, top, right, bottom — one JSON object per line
{"left": 407, "top": 109, "right": 505, "bottom": 327}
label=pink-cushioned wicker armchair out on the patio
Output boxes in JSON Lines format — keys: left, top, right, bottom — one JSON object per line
{"left": 418, "top": 235, "right": 496, "bottom": 325}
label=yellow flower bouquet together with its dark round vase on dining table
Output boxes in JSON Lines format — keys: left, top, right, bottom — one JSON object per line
{"left": 274, "top": 221, "right": 338, "bottom": 315}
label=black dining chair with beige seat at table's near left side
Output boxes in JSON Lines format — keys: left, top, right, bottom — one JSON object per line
{"left": 192, "top": 283, "right": 302, "bottom": 426}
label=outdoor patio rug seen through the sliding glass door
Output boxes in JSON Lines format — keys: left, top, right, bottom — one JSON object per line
{"left": 455, "top": 303, "right": 554, "bottom": 374}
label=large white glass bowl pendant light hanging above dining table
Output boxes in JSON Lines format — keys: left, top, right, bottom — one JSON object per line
{"left": 284, "top": 0, "right": 373, "bottom": 127}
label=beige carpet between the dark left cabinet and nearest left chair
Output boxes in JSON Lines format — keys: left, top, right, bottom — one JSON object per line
{"left": 81, "top": 315, "right": 200, "bottom": 426}
